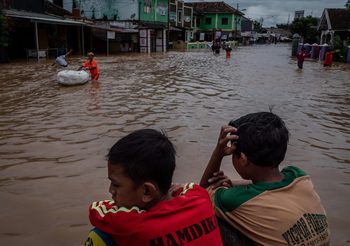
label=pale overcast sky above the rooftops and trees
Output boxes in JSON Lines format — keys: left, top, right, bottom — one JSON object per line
{"left": 187, "top": 0, "right": 347, "bottom": 27}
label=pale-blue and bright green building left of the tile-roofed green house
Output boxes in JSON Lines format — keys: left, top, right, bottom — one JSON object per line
{"left": 63, "top": 0, "right": 168, "bottom": 53}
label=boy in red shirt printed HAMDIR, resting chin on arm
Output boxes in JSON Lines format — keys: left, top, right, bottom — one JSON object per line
{"left": 87, "top": 129, "right": 222, "bottom": 246}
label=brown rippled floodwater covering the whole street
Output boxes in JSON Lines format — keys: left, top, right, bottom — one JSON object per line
{"left": 0, "top": 44, "right": 350, "bottom": 246}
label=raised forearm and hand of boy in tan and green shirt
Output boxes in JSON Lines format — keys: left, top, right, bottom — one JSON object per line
{"left": 200, "top": 126, "right": 238, "bottom": 188}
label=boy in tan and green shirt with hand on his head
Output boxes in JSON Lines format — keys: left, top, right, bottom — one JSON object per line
{"left": 200, "top": 112, "right": 330, "bottom": 246}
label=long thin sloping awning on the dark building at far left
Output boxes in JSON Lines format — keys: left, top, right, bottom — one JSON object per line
{"left": 3, "top": 9, "right": 86, "bottom": 26}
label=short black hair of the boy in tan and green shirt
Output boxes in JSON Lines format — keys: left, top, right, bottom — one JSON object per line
{"left": 229, "top": 112, "right": 289, "bottom": 167}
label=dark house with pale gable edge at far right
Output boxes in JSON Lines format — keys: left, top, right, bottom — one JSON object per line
{"left": 317, "top": 8, "right": 350, "bottom": 44}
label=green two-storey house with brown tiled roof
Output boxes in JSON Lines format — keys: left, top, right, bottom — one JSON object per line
{"left": 187, "top": 2, "right": 243, "bottom": 41}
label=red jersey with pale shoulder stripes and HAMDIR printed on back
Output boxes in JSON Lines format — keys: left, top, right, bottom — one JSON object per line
{"left": 89, "top": 183, "right": 222, "bottom": 246}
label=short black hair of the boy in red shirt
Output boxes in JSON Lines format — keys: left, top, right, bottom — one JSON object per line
{"left": 107, "top": 129, "right": 176, "bottom": 194}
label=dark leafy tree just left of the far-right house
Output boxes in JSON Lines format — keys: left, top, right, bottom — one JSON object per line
{"left": 290, "top": 16, "right": 319, "bottom": 44}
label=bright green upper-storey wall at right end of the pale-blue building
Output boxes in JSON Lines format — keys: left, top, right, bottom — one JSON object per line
{"left": 139, "top": 0, "right": 168, "bottom": 23}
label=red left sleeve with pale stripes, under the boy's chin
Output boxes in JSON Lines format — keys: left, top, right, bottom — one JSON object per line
{"left": 89, "top": 200, "right": 145, "bottom": 238}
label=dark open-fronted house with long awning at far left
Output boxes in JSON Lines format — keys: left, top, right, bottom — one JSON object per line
{"left": 3, "top": 0, "right": 86, "bottom": 60}
